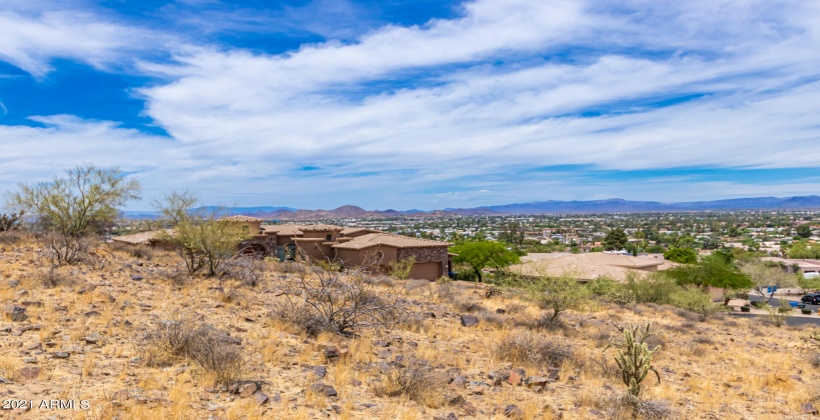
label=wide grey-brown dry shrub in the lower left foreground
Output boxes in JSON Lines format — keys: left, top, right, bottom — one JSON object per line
{"left": 140, "top": 319, "right": 244, "bottom": 384}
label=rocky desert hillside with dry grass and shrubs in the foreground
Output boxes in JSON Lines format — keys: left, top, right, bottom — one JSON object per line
{"left": 0, "top": 231, "right": 820, "bottom": 419}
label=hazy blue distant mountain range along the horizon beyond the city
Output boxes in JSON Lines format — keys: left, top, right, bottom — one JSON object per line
{"left": 123, "top": 195, "right": 820, "bottom": 220}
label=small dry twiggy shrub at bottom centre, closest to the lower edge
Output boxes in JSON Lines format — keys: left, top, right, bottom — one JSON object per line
{"left": 373, "top": 358, "right": 447, "bottom": 407}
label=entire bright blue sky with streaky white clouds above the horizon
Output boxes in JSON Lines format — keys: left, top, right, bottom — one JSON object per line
{"left": 0, "top": 0, "right": 820, "bottom": 209}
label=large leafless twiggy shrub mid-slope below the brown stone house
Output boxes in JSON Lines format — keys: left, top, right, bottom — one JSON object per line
{"left": 272, "top": 266, "right": 417, "bottom": 335}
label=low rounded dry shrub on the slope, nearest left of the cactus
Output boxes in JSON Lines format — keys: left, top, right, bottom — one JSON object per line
{"left": 494, "top": 333, "right": 574, "bottom": 366}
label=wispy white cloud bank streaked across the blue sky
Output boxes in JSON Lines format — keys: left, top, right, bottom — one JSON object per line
{"left": 0, "top": 0, "right": 820, "bottom": 207}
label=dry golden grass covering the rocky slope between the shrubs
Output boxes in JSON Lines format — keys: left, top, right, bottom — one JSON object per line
{"left": 0, "top": 238, "right": 820, "bottom": 419}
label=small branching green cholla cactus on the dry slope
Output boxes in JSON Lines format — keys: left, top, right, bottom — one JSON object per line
{"left": 604, "top": 322, "right": 661, "bottom": 402}
